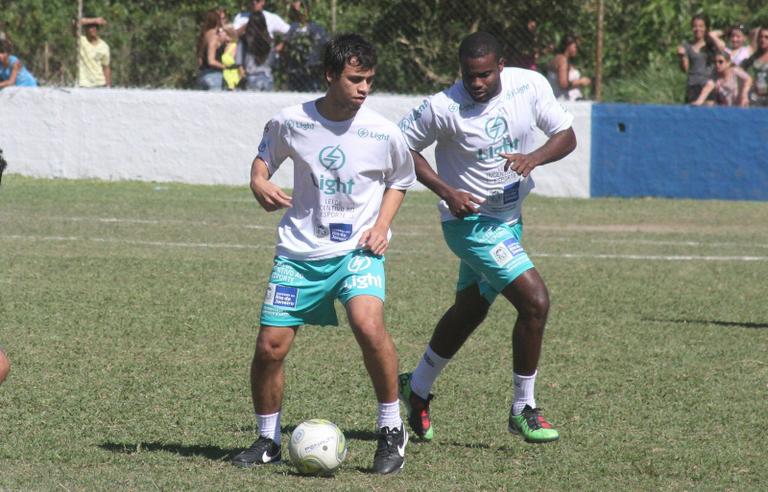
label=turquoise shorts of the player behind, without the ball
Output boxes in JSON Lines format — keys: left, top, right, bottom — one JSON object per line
{"left": 443, "top": 215, "right": 533, "bottom": 303}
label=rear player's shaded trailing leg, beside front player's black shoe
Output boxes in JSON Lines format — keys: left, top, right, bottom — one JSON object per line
{"left": 399, "top": 276, "right": 490, "bottom": 441}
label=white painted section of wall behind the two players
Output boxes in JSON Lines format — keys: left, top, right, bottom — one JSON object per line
{"left": 0, "top": 87, "right": 591, "bottom": 197}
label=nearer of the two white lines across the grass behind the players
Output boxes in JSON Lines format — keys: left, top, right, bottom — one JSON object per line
{"left": 0, "top": 235, "right": 768, "bottom": 261}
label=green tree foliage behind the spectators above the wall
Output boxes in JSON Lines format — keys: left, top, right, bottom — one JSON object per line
{"left": 0, "top": 0, "right": 768, "bottom": 102}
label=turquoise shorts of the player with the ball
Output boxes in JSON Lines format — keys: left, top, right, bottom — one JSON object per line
{"left": 261, "top": 250, "right": 385, "bottom": 326}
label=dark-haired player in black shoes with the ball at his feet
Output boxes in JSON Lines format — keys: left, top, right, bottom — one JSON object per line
{"left": 232, "top": 34, "right": 416, "bottom": 474}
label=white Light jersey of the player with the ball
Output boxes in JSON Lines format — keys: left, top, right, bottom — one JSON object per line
{"left": 259, "top": 101, "right": 416, "bottom": 260}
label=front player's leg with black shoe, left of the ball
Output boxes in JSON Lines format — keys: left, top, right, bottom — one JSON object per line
{"left": 232, "top": 326, "right": 297, "bottom": 467}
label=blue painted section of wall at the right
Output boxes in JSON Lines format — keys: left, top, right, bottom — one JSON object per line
{"left": 590, "top": 104, "right": 768, "bottom": 200}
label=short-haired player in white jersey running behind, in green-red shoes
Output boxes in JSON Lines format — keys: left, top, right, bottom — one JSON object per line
{"left": 400, "top": 32, "right": 576, "bottom": 442}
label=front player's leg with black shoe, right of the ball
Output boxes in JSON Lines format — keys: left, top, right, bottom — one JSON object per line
{"left": 346, "top": 295, "right": 408, "bottom": 474}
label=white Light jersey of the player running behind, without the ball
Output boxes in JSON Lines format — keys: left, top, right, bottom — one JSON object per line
{"left": 400, "top": 68, "right": 573, "bottom": 224}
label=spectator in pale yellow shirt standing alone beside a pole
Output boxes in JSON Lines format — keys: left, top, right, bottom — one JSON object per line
{"left": 77, "top": 17, "right": 112, "bottom": 87}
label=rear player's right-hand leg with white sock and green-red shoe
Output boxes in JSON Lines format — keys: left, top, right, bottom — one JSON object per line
{"left": 502, "top": 268, "right": 560, "bottom": 443}
